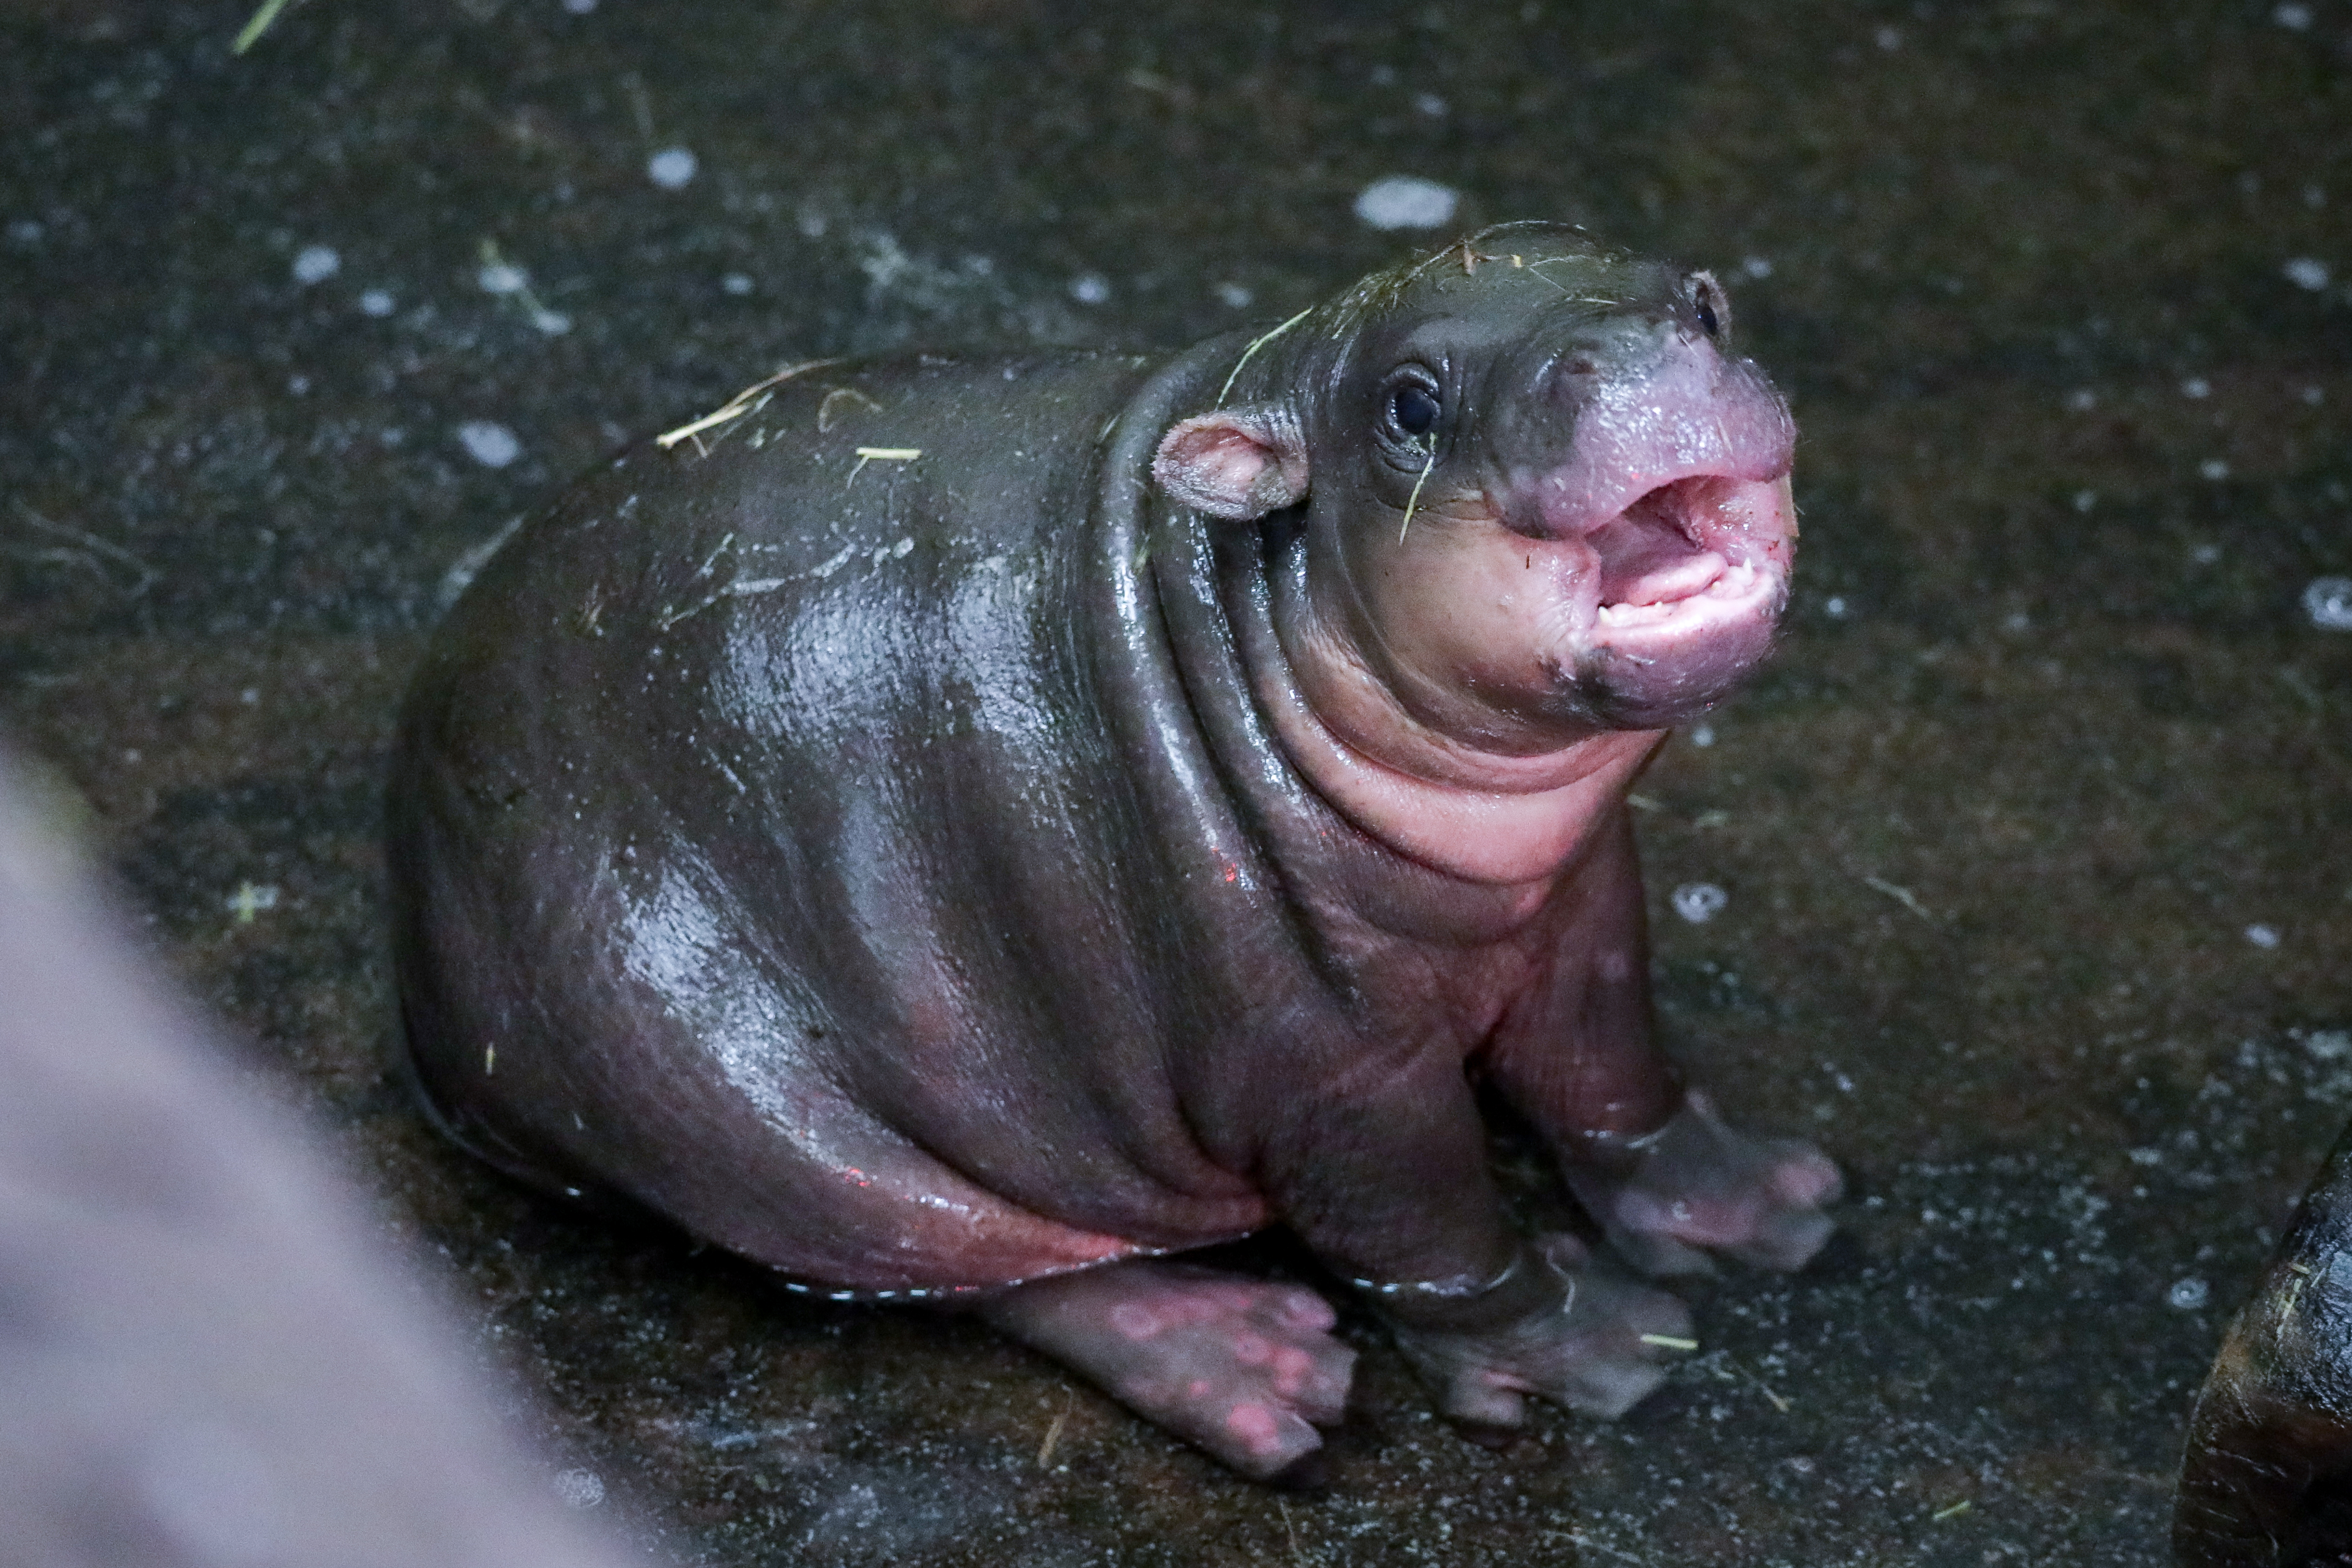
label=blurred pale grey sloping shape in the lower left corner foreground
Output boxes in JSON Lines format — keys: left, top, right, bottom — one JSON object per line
{"left": 0, "top": 761, "right": 644, "bottom": 1568}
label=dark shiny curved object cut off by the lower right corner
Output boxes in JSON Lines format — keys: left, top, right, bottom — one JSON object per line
{"left": 2173, "top": 1131, "right": 2352, "bottom": 1568}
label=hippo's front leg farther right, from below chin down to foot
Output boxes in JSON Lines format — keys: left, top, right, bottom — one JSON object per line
{"left": 1494, "top": 807, "right": 1841, "bottom": 1274}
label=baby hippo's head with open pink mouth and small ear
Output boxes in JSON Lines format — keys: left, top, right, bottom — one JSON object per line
{"left": 1153, "top": 223, "right": 1797, "bottom": 774}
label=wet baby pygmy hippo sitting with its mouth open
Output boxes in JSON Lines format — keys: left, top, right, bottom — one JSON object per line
{"left": 390, "top": 223, "right": 1839, "bottom": 1476}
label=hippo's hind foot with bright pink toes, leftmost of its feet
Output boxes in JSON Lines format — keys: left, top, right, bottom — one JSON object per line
{"left": 981, "top": 1262, "right": 1355, "bottom": 1481}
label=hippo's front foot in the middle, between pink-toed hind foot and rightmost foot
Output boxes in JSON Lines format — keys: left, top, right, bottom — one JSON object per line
{"left": 1395, "top": 1237, "right": 1691, "bottom": 1427}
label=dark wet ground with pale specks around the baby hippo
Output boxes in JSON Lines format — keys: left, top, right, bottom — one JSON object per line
{"left": 0, "top": 0, "right": 2352, "bottom": 1568}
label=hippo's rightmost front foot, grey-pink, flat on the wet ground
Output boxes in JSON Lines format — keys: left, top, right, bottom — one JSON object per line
{"left": 1566, "top": 1091, "right": 1844, "bottom": 1274}
